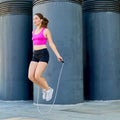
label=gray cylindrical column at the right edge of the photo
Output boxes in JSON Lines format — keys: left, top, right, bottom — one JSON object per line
{"left": 83, "top": 0, "right": 120, "bottom": 100}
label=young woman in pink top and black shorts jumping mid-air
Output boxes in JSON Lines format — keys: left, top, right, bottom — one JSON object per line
{"left": 28, "top": 13, "right": 63, "bottom": 101}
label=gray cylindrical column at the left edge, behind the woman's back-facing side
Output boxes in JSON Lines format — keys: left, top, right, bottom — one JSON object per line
{"left": 0, "top": 0, "right": 32, "bottom": 100}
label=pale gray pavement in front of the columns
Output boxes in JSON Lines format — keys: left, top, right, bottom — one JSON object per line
{"left": 0, "top": 100, "right": 120, "bottom": 120}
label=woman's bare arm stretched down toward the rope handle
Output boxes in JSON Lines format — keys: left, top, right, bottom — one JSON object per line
{"left": 45, "top": 29, "right": 63, "bottom": 61}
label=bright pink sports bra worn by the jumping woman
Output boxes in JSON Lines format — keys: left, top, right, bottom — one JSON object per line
{"left": 32, "top": 28, "right": 47, "bottom": 45}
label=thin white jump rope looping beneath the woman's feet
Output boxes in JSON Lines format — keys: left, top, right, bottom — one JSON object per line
{"left": 37, "top": 61, "right": 64, "bottom": 114}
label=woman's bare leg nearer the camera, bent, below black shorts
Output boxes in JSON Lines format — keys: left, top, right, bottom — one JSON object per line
{"left": 35, "top": 62, "right": 49, "bottom": 90}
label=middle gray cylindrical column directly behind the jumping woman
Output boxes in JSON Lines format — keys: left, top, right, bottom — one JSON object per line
{"left": 33, "top": 0, "right": 83, "bottom": 104}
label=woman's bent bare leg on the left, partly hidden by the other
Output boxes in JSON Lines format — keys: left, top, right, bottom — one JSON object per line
{"left": 28, "top": 61, "right": 38, "bottom": 85}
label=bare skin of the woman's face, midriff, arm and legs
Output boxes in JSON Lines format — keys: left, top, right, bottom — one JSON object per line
{"left": 28, "top": 15, "right": 63, "bottom": 90}
